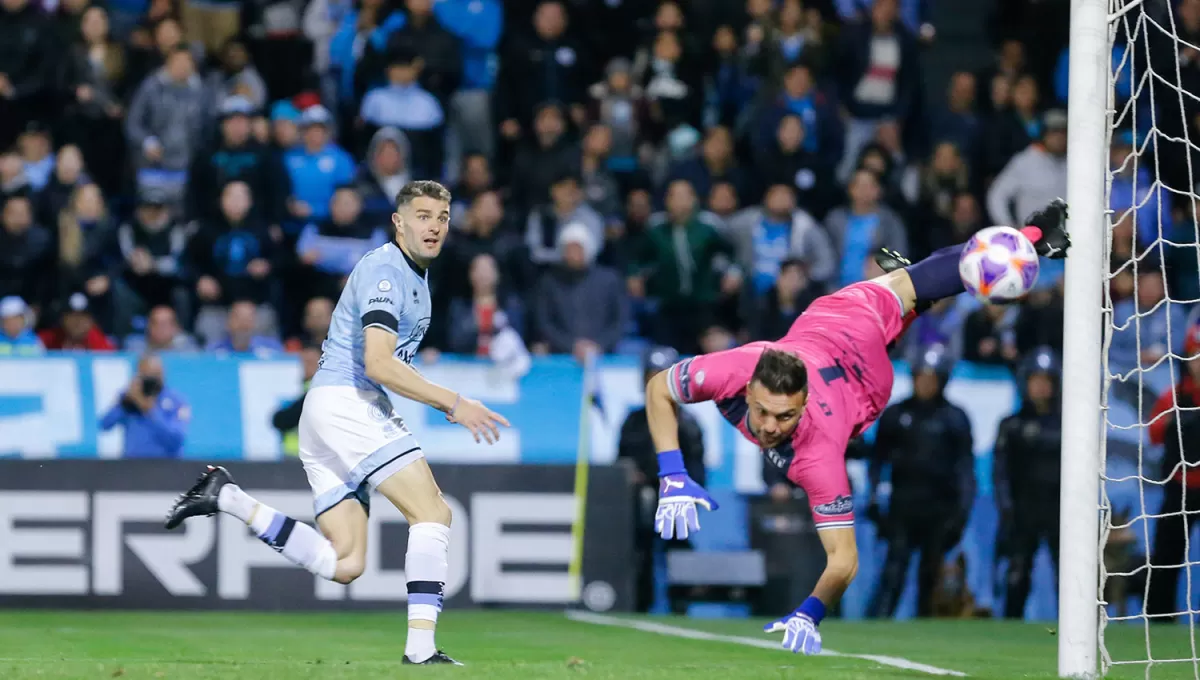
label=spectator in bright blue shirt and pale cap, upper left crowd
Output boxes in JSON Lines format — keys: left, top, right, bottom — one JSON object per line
{"left": 283, "top": 104, "right": 354, "bottom": 224}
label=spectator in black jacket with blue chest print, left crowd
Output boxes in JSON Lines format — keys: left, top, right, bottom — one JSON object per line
{"left": 188, "top": 181, "right": 278, "bottom": 338}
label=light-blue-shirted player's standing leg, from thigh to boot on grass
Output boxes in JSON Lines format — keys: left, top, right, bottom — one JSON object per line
{"left": 376, "top": 458, "right": 461, "bottom": 666}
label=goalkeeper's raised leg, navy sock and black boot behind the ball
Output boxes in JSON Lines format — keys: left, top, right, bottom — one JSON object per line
{"left": 874, "top": 199, "right": 1070, "bottom": 314}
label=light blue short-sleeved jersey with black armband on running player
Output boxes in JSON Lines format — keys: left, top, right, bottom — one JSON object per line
{"left": 312, "top": 242, "right": 430, "bottom": 395}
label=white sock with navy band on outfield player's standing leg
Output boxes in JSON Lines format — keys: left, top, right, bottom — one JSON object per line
{"left": 404, "top": 522, "right": 450, "bottom": 662}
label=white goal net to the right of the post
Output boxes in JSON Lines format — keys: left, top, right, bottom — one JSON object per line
{"left": 1099, "top": 0, "right": 1200, "bottom": 680}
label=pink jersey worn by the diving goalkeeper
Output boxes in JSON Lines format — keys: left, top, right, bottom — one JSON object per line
{"left": 667, "top": 282, "right": 904, "bottom": 529}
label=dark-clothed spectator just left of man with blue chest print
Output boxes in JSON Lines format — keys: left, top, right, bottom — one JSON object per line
{"left": 116, "top": 188, "right": 188, "bottom": 321}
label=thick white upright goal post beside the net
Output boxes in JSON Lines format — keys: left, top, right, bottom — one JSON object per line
{"left": 1058, "top": 0, "right": 1112, "bottom": 679}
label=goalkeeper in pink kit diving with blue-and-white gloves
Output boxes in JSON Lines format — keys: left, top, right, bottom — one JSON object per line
{"left": 646, "top": 200, "right": 1070, "bottom": 654}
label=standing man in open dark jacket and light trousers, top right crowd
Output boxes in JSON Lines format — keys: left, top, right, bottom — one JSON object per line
{"left": 838, "top": 0, "right": 919, "bottom": 177}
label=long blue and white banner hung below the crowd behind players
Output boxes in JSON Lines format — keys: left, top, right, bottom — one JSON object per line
{"left": 0, "top": 354, "right": 1016, "bottom": 493}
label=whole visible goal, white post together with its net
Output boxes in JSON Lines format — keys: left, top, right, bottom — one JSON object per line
{"left": 1058, "top": 0, "right": 1200, "bottom": 680}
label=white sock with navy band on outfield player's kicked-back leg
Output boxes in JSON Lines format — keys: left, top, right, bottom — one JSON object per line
{"left": 224, "top": 485, "right": 337, "bottom": 580}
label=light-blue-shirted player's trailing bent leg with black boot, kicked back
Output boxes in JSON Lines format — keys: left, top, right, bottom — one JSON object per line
{"left": 166, "top": 465, "right": 367, "bottom": 583}
